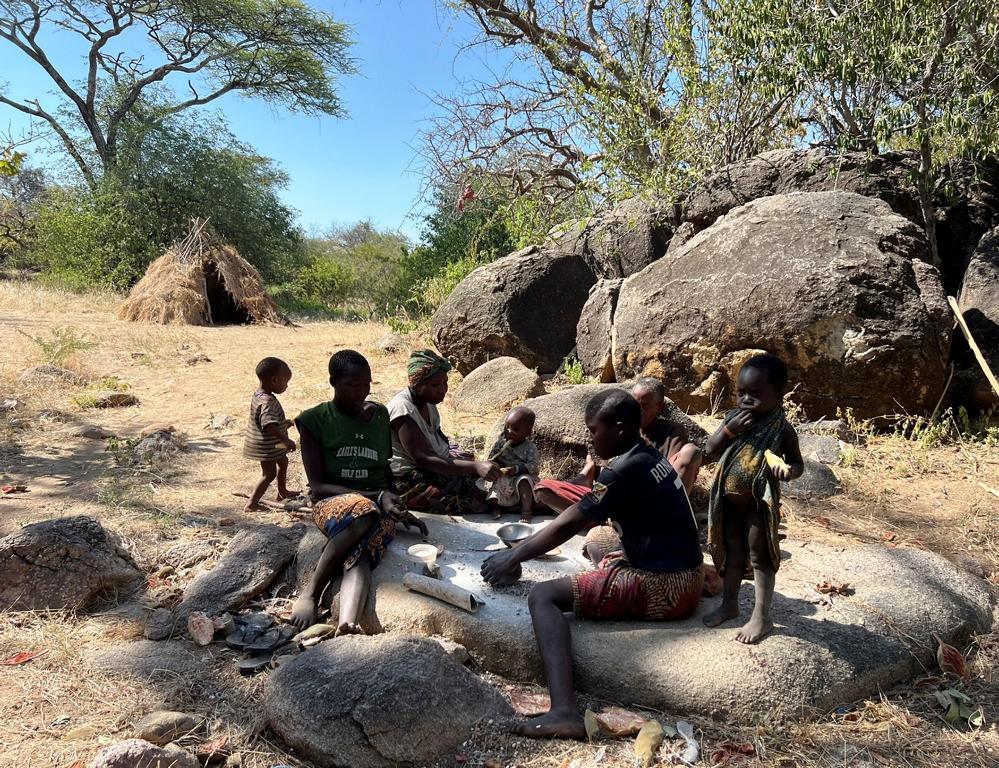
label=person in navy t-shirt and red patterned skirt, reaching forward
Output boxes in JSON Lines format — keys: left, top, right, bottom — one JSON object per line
{"left": 482, "top": 389, "right": 704, "bottom": 739}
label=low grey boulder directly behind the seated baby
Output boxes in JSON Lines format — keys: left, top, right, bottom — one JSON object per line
{"left": 489, "top": 384, "right": 708, "bottom": 478}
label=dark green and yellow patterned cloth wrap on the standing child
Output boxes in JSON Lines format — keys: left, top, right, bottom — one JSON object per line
{"left": 708, "top": 407, "right": 787, "bottom": 573}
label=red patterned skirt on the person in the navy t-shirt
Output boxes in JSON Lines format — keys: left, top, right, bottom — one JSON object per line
{"left": 571, "top": 525, "right": 704, "bottom": 621}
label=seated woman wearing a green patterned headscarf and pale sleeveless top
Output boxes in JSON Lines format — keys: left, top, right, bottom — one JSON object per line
{"left": 388, "top": 349, "right": 500, "bottom": 513}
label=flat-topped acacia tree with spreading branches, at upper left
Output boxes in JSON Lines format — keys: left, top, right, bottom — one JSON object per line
{"left": 0, "top": 0, "right": 353, "bottom": 188}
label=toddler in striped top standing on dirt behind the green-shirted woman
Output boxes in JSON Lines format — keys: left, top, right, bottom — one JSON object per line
{"left": 243, "top": 357, "right": 300, "bottom": 512}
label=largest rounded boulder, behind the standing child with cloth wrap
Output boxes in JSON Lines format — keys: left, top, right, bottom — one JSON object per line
{"left": 613, "top": 192, "right": 951, "bottom": 418}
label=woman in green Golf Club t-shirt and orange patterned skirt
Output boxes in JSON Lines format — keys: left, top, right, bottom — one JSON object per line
{"left": 291, "top": 350, "right": 427, "bottom": 635}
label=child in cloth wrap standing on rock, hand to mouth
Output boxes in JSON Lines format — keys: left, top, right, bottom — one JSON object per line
{"left": 704, "top": 355, "right": 805, "bottom": 644}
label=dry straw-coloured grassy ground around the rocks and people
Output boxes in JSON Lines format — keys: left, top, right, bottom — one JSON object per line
{"left": 0, "top": 281, "right": 999, "bottom": 768}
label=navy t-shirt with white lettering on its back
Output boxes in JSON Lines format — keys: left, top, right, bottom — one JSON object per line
{"left": 578, "top": 443, "right": 702, "bottom": 573}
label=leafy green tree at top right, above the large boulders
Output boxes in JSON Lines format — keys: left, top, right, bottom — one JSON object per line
{"left": 723, "top": 0, "right": 999, "bottom": 266}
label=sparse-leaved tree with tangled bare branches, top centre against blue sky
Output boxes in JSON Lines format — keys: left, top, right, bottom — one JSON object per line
{"left": 425, "top": 0, "right": 794, "bottom": 207}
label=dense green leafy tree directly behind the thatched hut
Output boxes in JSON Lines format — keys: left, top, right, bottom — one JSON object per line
{"left": 32, "top": 115, "right": 303, "bottom": 289}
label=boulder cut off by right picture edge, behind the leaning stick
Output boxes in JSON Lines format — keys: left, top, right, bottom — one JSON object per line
{"left": 953, "top": 228, "right": 999, "bottom": 410}
